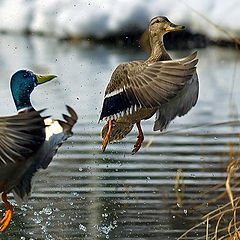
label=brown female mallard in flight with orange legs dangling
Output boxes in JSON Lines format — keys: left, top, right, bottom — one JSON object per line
{"left": 99, "top": 16, "right": 199, "bottom": 154}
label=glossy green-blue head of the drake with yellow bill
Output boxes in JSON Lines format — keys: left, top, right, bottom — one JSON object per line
{"left": 10, "top": 70, "right": 56, "bottom": 110}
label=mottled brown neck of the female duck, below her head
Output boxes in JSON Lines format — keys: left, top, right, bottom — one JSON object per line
{"left": 147, "top": 36, "right": 171, "bottom": 62}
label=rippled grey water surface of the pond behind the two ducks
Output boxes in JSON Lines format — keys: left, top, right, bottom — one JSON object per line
{"left": 0, "top": 36, "right": 240, "bottom": 240}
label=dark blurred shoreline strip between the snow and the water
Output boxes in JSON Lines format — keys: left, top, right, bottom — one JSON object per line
{"left": 0, "top": 30, "right": 238, "bottom": 50}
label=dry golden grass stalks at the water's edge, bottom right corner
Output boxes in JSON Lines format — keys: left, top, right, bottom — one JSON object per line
{"left": 177, "top": 136, "right": 240, "bottom": 240}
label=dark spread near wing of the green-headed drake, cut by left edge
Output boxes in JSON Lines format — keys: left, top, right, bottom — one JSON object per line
{"left": 0, "top": 111, "right": 45, "bottom": 168}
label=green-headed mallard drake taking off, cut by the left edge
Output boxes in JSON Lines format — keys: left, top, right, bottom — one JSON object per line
{"left": 0, "top": 70, "right": 78, "bottom": 231}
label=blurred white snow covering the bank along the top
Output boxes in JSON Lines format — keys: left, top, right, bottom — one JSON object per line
{"left": 0, "top": 0, "right": 240, "bottom": 39}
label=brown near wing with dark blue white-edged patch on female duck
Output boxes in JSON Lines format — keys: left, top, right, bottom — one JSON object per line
{"left": 100, "top": 52, "right": 198, "bottom": 120}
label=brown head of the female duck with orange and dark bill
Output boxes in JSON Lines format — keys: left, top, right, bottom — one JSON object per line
{"left": 148, "top": 16, "right": 185, "bottom": 39}
